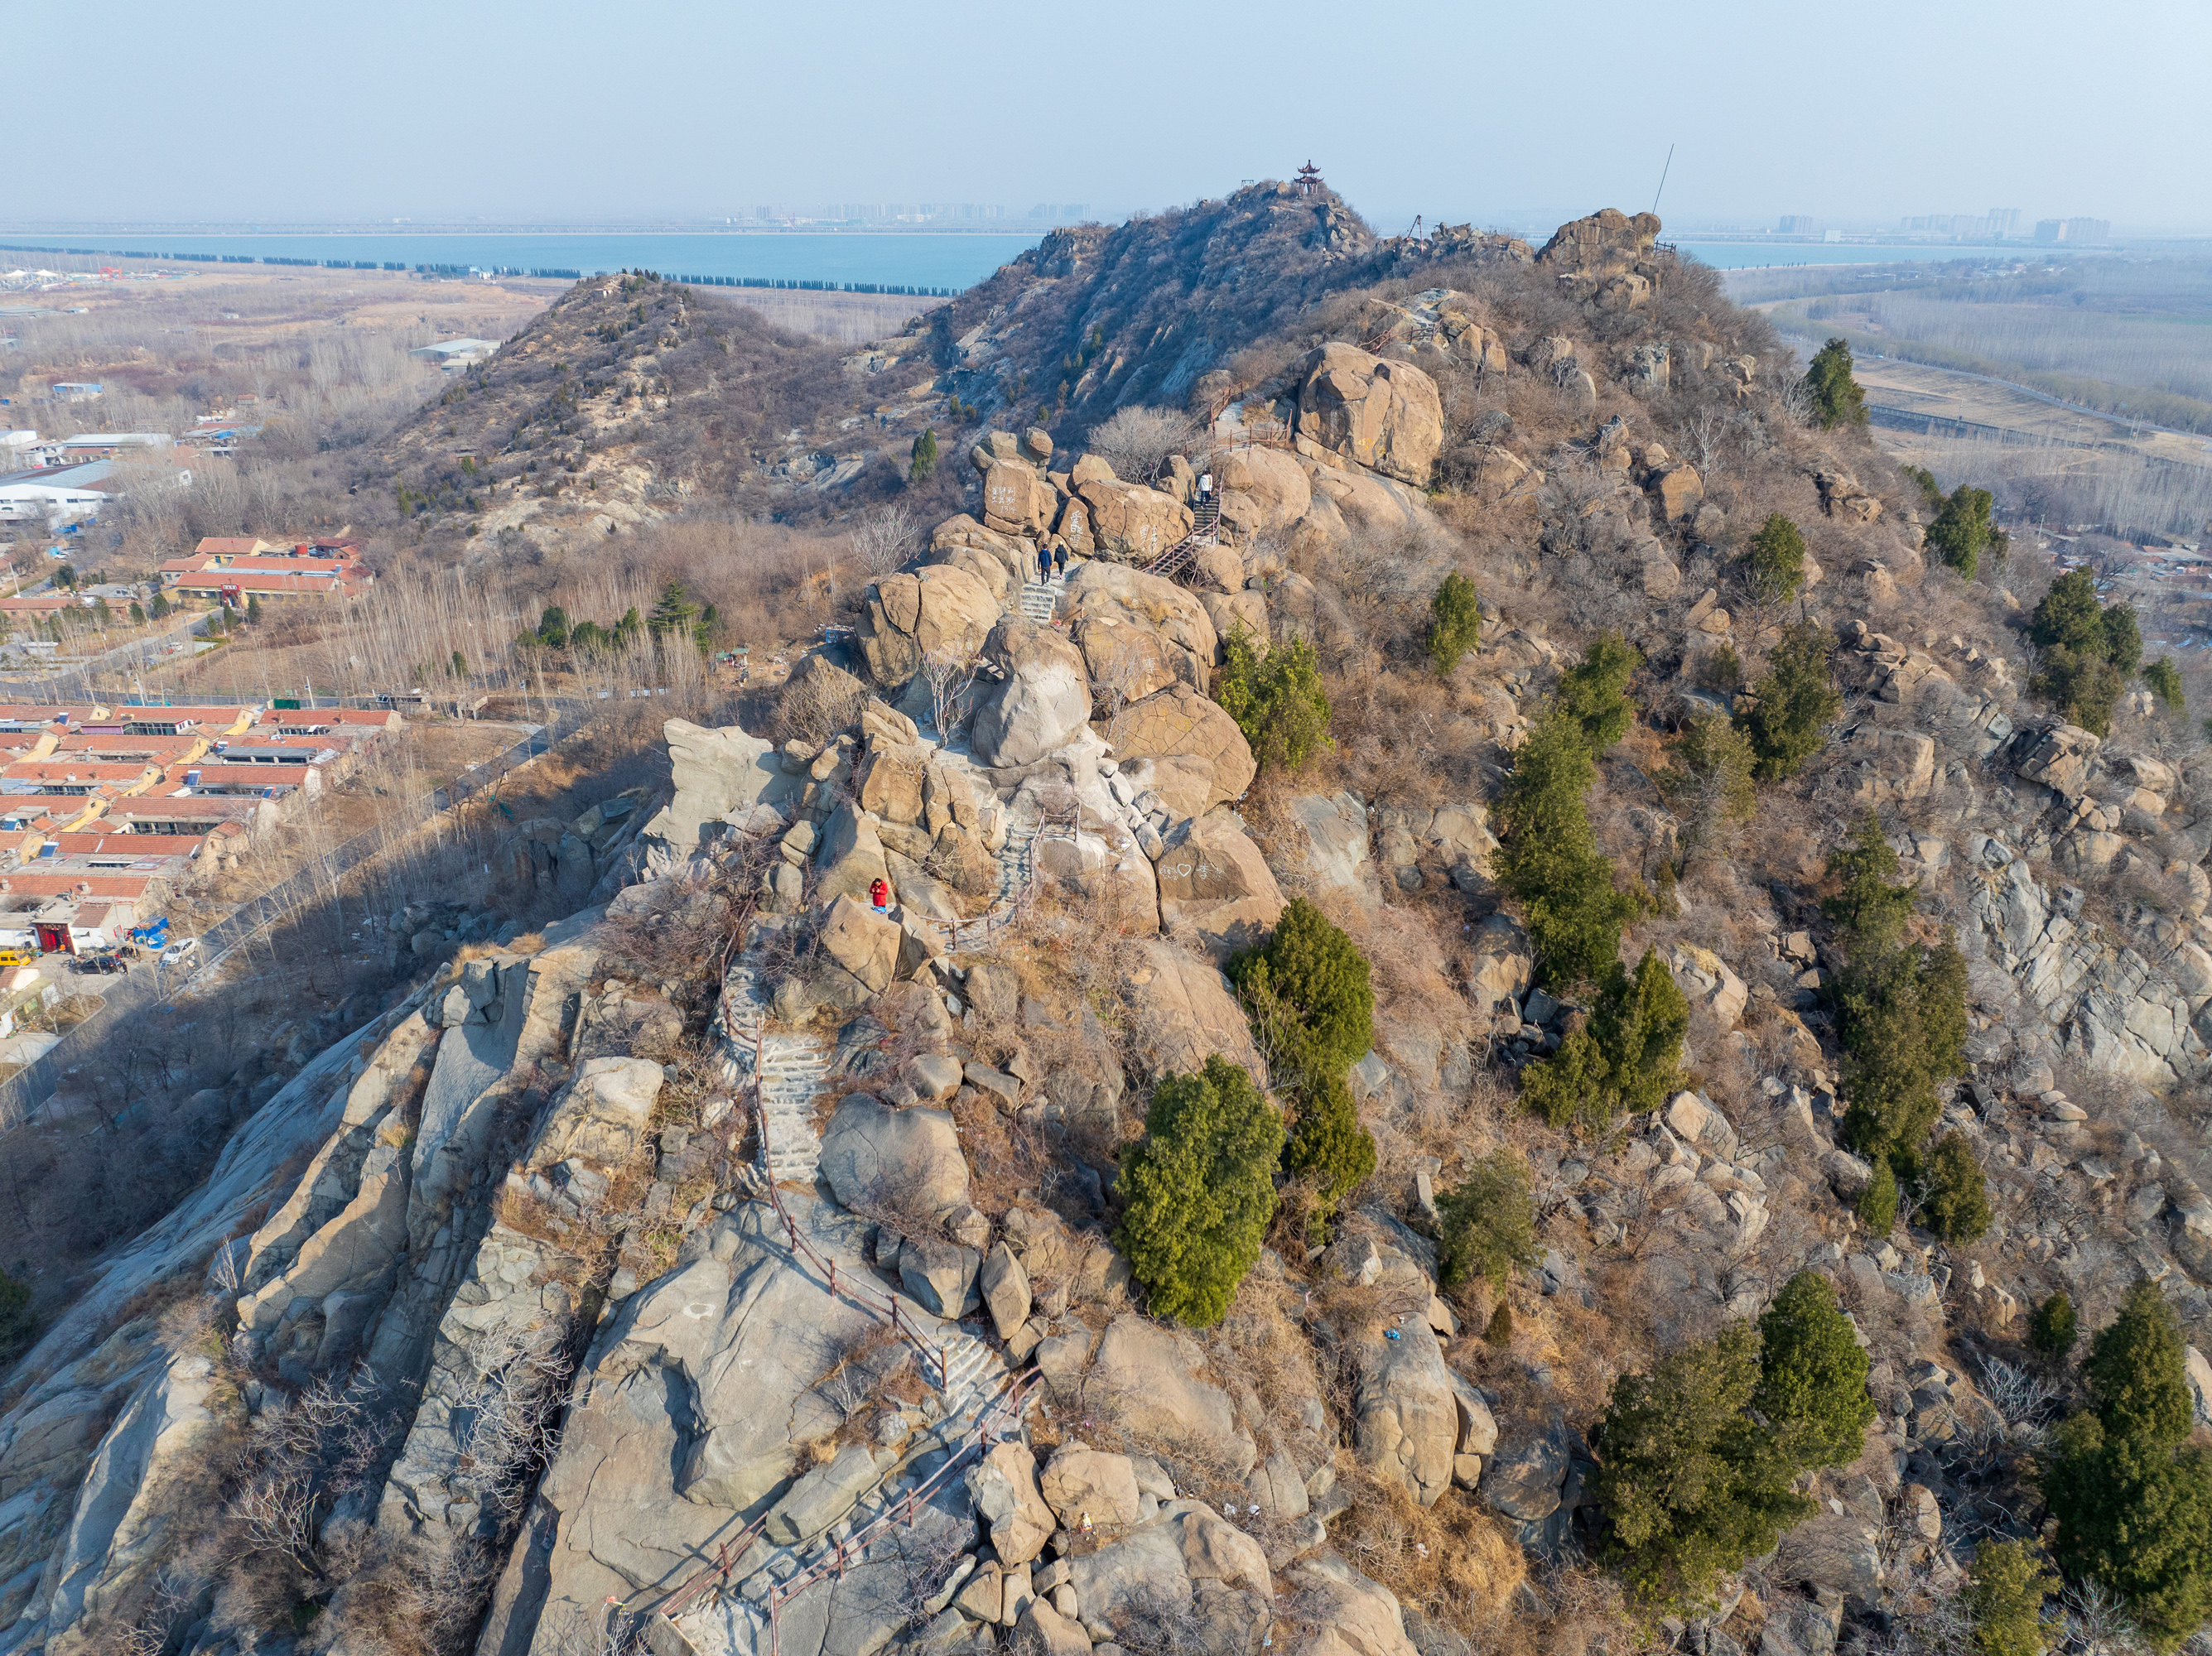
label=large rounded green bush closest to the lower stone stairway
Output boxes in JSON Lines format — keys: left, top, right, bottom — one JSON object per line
{"left": 1117, "top": 1055, "right": 1283, "bottom": 1326}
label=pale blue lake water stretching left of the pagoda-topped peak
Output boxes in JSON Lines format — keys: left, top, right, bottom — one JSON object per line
{"left": 0, "top": 230, "right": 1038, "bottom": 290}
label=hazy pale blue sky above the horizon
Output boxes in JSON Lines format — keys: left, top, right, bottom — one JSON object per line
{"left": 22, "top": 0, "right": 2212, "bottom": 230}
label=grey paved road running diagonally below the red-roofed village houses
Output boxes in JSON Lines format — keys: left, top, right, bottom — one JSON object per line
{"left": 0, "top": 707, "right": 588, "bottom": 1125}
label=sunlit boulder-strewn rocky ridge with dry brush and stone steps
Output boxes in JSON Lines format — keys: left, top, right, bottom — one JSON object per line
{"left": 0, "top": 192, "right": 2212, "bottom": 1656}
